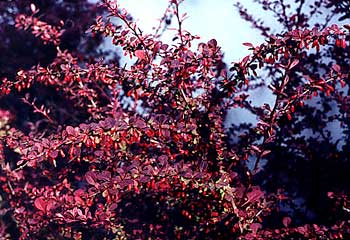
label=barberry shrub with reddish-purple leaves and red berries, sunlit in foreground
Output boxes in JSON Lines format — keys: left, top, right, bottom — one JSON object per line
{"left": 0, "top": 0, "right": 350, "bottom": 239}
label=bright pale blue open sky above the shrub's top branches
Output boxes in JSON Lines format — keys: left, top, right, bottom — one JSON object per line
{"left": 118, "top": 0, "right": 263, "bottom": 63}
